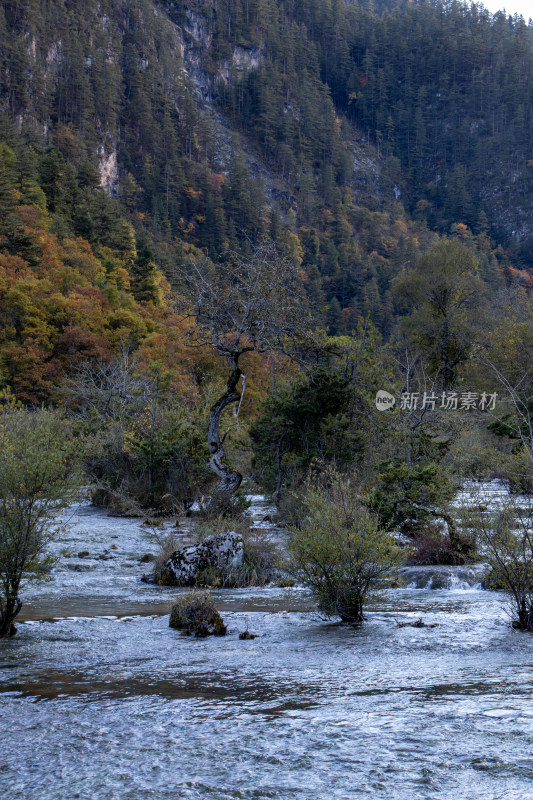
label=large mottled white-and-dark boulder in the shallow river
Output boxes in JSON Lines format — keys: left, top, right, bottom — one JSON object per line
{"left": 161, "top": 531, "right": 244, "bottom": 586}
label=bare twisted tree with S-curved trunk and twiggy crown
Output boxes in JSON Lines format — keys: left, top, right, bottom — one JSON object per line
{"left": 178, "top": 242, "right": 310, "bottom": 494}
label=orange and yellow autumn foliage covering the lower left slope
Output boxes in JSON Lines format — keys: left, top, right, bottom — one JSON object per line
{"left": 0, "top": 206, "right": 162, "bottom": 403}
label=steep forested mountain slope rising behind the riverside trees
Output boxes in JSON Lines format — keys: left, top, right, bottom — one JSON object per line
{"left": 0, "top": 0, "right": 533, "bottom": 398}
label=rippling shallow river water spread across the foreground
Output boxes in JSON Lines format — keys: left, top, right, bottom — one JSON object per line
{"left": 0, "top": 496, "right": 533, "bottom": 800}
